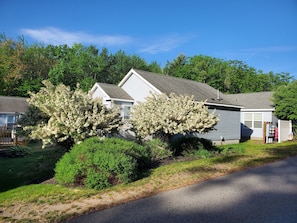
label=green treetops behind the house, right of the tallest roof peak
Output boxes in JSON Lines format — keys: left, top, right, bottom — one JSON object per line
{"left": 164, "top": 55, "right": 293, "bottom": 94}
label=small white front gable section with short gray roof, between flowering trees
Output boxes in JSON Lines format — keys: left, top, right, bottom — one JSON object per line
{"left": 90, "top": 83, "right": 134, "bottom": 119}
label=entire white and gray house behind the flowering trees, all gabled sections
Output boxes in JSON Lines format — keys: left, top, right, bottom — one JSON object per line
{"left": 92, "top": 69, "right": 292, "bottom": 143}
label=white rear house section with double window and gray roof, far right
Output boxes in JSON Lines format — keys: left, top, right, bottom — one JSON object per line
{"left": 226, "top": 92, "right": 278, "bottom": 139}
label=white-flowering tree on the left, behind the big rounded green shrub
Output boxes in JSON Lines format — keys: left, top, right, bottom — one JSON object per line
{"left": 25, "top": 81, "right": 120, "bottom": 146}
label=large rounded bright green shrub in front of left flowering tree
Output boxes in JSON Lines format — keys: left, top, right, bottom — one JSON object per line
{"left": 55, "top": 137, "right": 150, "bottom": 189}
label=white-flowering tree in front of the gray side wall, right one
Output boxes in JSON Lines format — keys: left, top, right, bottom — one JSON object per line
{"left": 131, "top": 94, "right": 218, "bottom": 140}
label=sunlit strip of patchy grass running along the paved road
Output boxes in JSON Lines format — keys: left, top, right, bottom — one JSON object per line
{"left": 0, "top": 141, "right": 297, "bottom": 222}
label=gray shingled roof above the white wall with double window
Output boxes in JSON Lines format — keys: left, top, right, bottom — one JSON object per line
{"left": 226, "top": 91, "right": 274, "bottom": 109}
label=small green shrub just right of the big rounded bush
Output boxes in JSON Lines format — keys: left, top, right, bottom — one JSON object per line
{"left": 145, "top": 138, "right": 172, "bottom": 161}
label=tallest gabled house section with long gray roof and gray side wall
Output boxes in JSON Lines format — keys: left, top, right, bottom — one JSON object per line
{"left": 118, "top": 69, "right": 242, "bottom": 143}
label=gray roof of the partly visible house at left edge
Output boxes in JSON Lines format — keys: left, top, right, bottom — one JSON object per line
{"left": 0, "top": 96, "right": 29, "bottom": 113}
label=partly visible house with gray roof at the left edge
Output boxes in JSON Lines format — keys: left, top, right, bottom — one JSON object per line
{"left": 0, "top": 96, "right": 28, "bottom": 129}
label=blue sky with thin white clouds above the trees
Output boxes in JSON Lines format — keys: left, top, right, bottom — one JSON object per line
{"left": 0, "top": 0, "right": 297, "bottom": 79}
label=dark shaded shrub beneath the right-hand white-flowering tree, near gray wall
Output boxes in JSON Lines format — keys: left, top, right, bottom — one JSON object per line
{"left": 170, "top": 136, "right": 215, "bottom": 156}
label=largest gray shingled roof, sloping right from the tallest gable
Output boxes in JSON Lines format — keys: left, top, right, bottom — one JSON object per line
{"left": 134, "top": 69, "right": 238, "bottom": 105}
